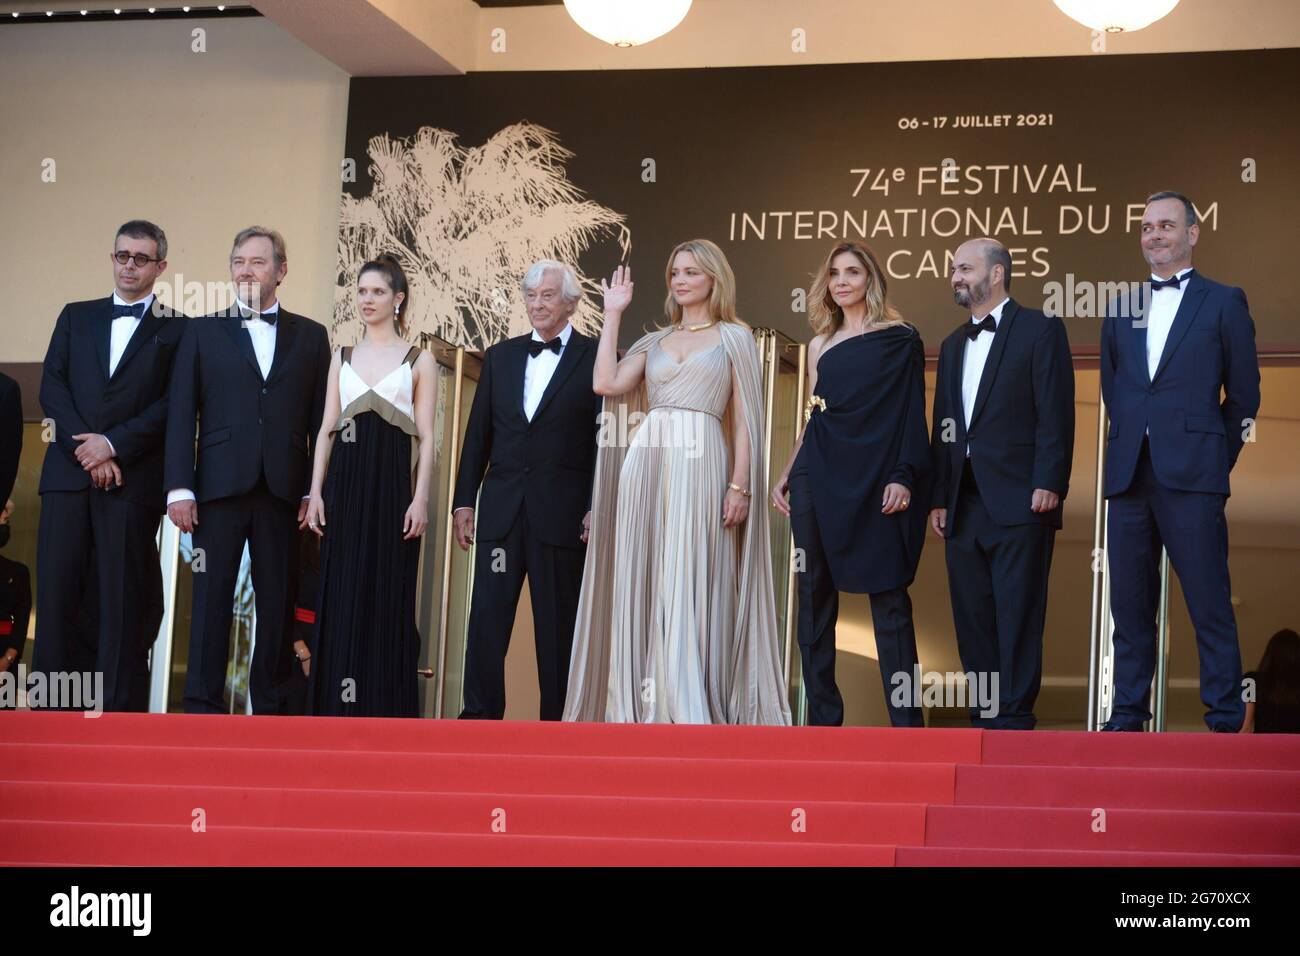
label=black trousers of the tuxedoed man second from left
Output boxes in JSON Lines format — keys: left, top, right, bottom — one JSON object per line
{"left": 185, "top": 481, "right": 298, "bottom": 714}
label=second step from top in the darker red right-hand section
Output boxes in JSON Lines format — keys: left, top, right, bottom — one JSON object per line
{"left": 953, "top": 766, "right": 1300, "bottom": 813}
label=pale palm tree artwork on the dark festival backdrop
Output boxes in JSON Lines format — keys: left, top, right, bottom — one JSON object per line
{"left": 332, "top": 122, "right": 632, "bottom": 349}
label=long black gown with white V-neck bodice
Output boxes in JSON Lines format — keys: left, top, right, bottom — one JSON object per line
{"left": 308, "top": 349, "right": 420, "bottom": 717}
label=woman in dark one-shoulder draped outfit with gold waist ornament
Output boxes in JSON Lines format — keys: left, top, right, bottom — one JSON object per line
{"left": 772, "top": 242, "right": 930, "bottom": 727}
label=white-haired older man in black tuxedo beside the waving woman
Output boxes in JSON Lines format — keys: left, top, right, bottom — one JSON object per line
{"left": 451, "top": 259, "right": 601, "bottom": 721}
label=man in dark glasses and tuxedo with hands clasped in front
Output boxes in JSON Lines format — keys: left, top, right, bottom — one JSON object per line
{"left": 33, "top": 220, "right": 189, "bottom": 710}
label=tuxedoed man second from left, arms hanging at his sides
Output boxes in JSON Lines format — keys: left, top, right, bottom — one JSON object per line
{"left": 165, "top": 226, "right": 330, "bottom": 714}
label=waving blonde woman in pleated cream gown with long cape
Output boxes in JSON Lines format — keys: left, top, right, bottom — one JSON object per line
{"left": 564, "top": 239, "right": 790, "bottom": 724}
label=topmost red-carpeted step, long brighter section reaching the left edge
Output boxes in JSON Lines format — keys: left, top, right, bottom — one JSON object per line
{"left": 0, "top": 710, "right": 982, "bottom": 763}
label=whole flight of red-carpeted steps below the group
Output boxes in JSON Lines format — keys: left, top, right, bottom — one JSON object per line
{"left": 0, "top": 711, "right": 1300, "bottom": 866}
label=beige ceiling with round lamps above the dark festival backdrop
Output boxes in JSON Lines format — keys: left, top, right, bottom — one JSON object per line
{"left": 0, "top": 0, "right": 1300, "bottom": 75}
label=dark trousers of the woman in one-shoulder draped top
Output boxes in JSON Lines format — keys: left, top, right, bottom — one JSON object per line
{"left": 790, "top": 470, "right": 926, "bottom": 727}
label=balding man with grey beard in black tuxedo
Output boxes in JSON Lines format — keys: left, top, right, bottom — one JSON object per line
{"left": 930, "top": 239, "right": 1074, "bottom": 730}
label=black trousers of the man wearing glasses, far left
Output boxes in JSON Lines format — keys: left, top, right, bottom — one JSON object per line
{"left": 33, "top": 488, "right": 163, "bottom": 710}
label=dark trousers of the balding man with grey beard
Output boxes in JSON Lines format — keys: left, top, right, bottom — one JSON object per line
{"left": 945, "top": 460, "right": 1056, "bottom": 730}
